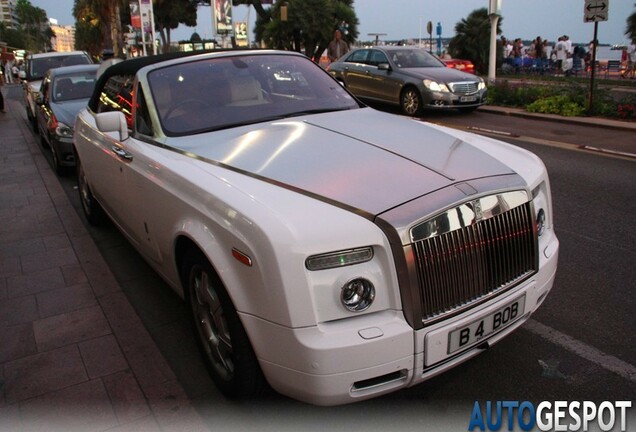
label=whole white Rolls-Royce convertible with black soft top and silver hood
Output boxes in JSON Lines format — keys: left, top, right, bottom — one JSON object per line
{"left": 75, "top": 51, "right": 558, "bottom": 405}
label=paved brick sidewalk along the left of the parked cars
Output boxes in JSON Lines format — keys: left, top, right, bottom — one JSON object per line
{"left": 0, "top": 98, "right": 209, "bottom": 432}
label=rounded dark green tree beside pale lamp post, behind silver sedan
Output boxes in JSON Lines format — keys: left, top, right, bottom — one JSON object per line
{"left": 448, "top": 8, "right": 503, "bottom": 73}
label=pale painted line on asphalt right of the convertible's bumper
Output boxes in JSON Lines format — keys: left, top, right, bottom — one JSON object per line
{"left": 522, "top": 319, "right": 636, "bottom": 383}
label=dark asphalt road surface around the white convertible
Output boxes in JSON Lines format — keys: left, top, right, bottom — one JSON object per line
{"left": 10, "top": 82, "right": 636, "bottom": 431}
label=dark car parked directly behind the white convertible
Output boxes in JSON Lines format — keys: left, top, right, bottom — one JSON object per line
{"left": 35, "top": 64, "right": 99, "bottom": 174}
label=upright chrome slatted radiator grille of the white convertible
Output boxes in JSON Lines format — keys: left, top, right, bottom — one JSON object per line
{"left": 412, "top": 196, "right": 538, "bottom": 322}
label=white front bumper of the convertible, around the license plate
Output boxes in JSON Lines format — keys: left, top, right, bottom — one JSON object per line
{"left": 241, "top": 234, "right": 558, "bottom": 405}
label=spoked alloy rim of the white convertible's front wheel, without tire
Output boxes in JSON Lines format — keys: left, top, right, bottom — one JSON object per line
{"left": 190, "top": 266, "right": 234, "bottom": 381}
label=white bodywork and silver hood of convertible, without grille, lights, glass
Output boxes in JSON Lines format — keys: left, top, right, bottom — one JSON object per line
{"left": 75, "top": 50, "right": 558, "bottom": 405}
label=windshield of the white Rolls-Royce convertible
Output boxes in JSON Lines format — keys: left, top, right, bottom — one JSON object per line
{"left": 148, "top": 54, "right": 359, "bottom": 136}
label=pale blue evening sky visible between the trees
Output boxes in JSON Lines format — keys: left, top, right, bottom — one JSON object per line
{"left": 31, "top": 0, "right": 636, "bottom": 44}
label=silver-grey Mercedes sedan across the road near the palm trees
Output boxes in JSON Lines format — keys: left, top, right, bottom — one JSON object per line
{"left": 327, "top": 46, "right": 486, "bottom": 116}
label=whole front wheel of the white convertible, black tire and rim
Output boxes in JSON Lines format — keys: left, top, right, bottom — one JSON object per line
{"left": 181, "top": 250, "right": 266, "bottom": 399}
